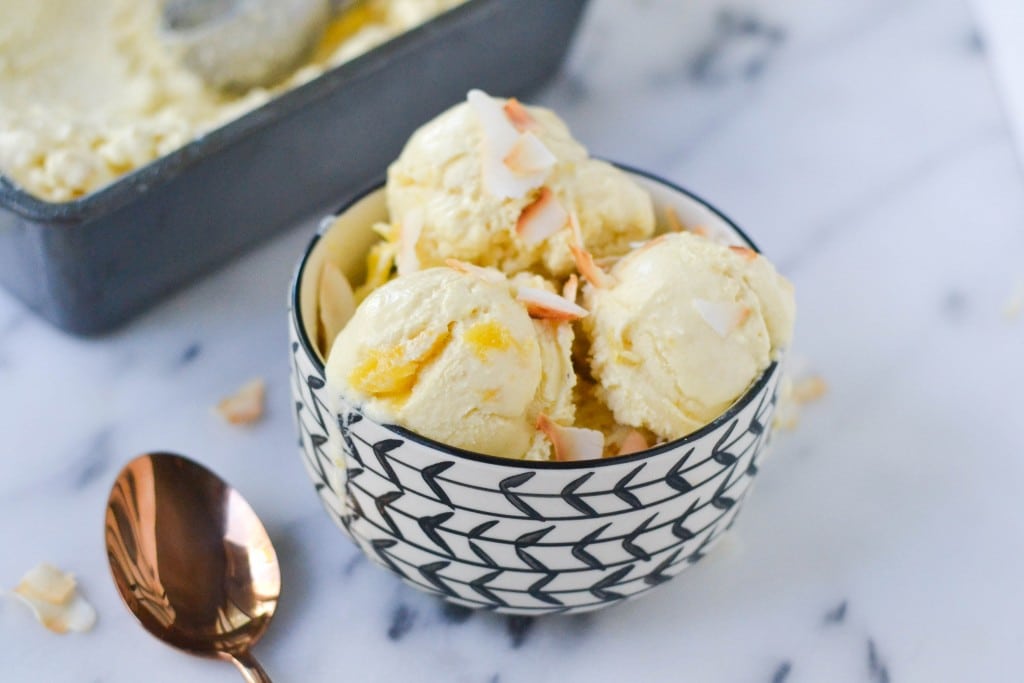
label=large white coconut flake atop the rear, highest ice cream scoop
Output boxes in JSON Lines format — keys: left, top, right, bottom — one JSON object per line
{"left": 466, "top": 90, "right": 548, "bottom": 199}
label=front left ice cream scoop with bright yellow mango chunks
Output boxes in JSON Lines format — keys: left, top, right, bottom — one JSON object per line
{"left": 327, "top": 267, "right": 574, "bottom": 460}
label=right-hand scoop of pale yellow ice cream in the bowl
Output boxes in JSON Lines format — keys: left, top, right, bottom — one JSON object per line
{"left": 584, "top": 233, "right": 795, "bottom": 439}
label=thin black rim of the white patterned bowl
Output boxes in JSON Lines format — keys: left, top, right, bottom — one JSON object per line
{"left": 289, "top": 162, "right": 778, "bottom": 470}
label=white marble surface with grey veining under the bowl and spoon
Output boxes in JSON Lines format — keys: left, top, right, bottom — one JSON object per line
{"left": 0, "top": 0, "right": 1024, "bottom": 683}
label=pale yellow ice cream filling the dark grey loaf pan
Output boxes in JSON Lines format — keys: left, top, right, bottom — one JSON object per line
{"left": 0, "top": 0, "right": 462, "bottom": 202}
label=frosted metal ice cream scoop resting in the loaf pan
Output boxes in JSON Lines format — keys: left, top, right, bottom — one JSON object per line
{"left": 161, "top": 0, "right": 353, "bottom": 92}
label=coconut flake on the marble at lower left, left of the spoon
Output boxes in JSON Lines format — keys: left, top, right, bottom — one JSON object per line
{"left": 12, "top": 564, "right": 96, "bottom": 633}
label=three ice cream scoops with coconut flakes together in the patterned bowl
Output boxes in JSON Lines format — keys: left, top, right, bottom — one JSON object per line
{"left": 321, "top": 91, "right": 795, "bottom": 460}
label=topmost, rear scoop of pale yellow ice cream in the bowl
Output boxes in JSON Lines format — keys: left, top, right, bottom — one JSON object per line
{"left": 387, "top": 91, "right": 654, "bottom": 275}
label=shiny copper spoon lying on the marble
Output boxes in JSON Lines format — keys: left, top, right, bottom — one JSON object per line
{"left": 105, "top": 453, "right": 281, "bottom": 683}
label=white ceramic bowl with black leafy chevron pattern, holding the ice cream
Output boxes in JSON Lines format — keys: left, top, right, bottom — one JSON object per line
{"left": 290, "top": 169, "right": 780, "bottom": 614}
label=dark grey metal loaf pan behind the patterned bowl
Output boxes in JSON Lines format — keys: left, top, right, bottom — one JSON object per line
{"left": 0, "top": 0, "right": 587, "bottom": 335}
